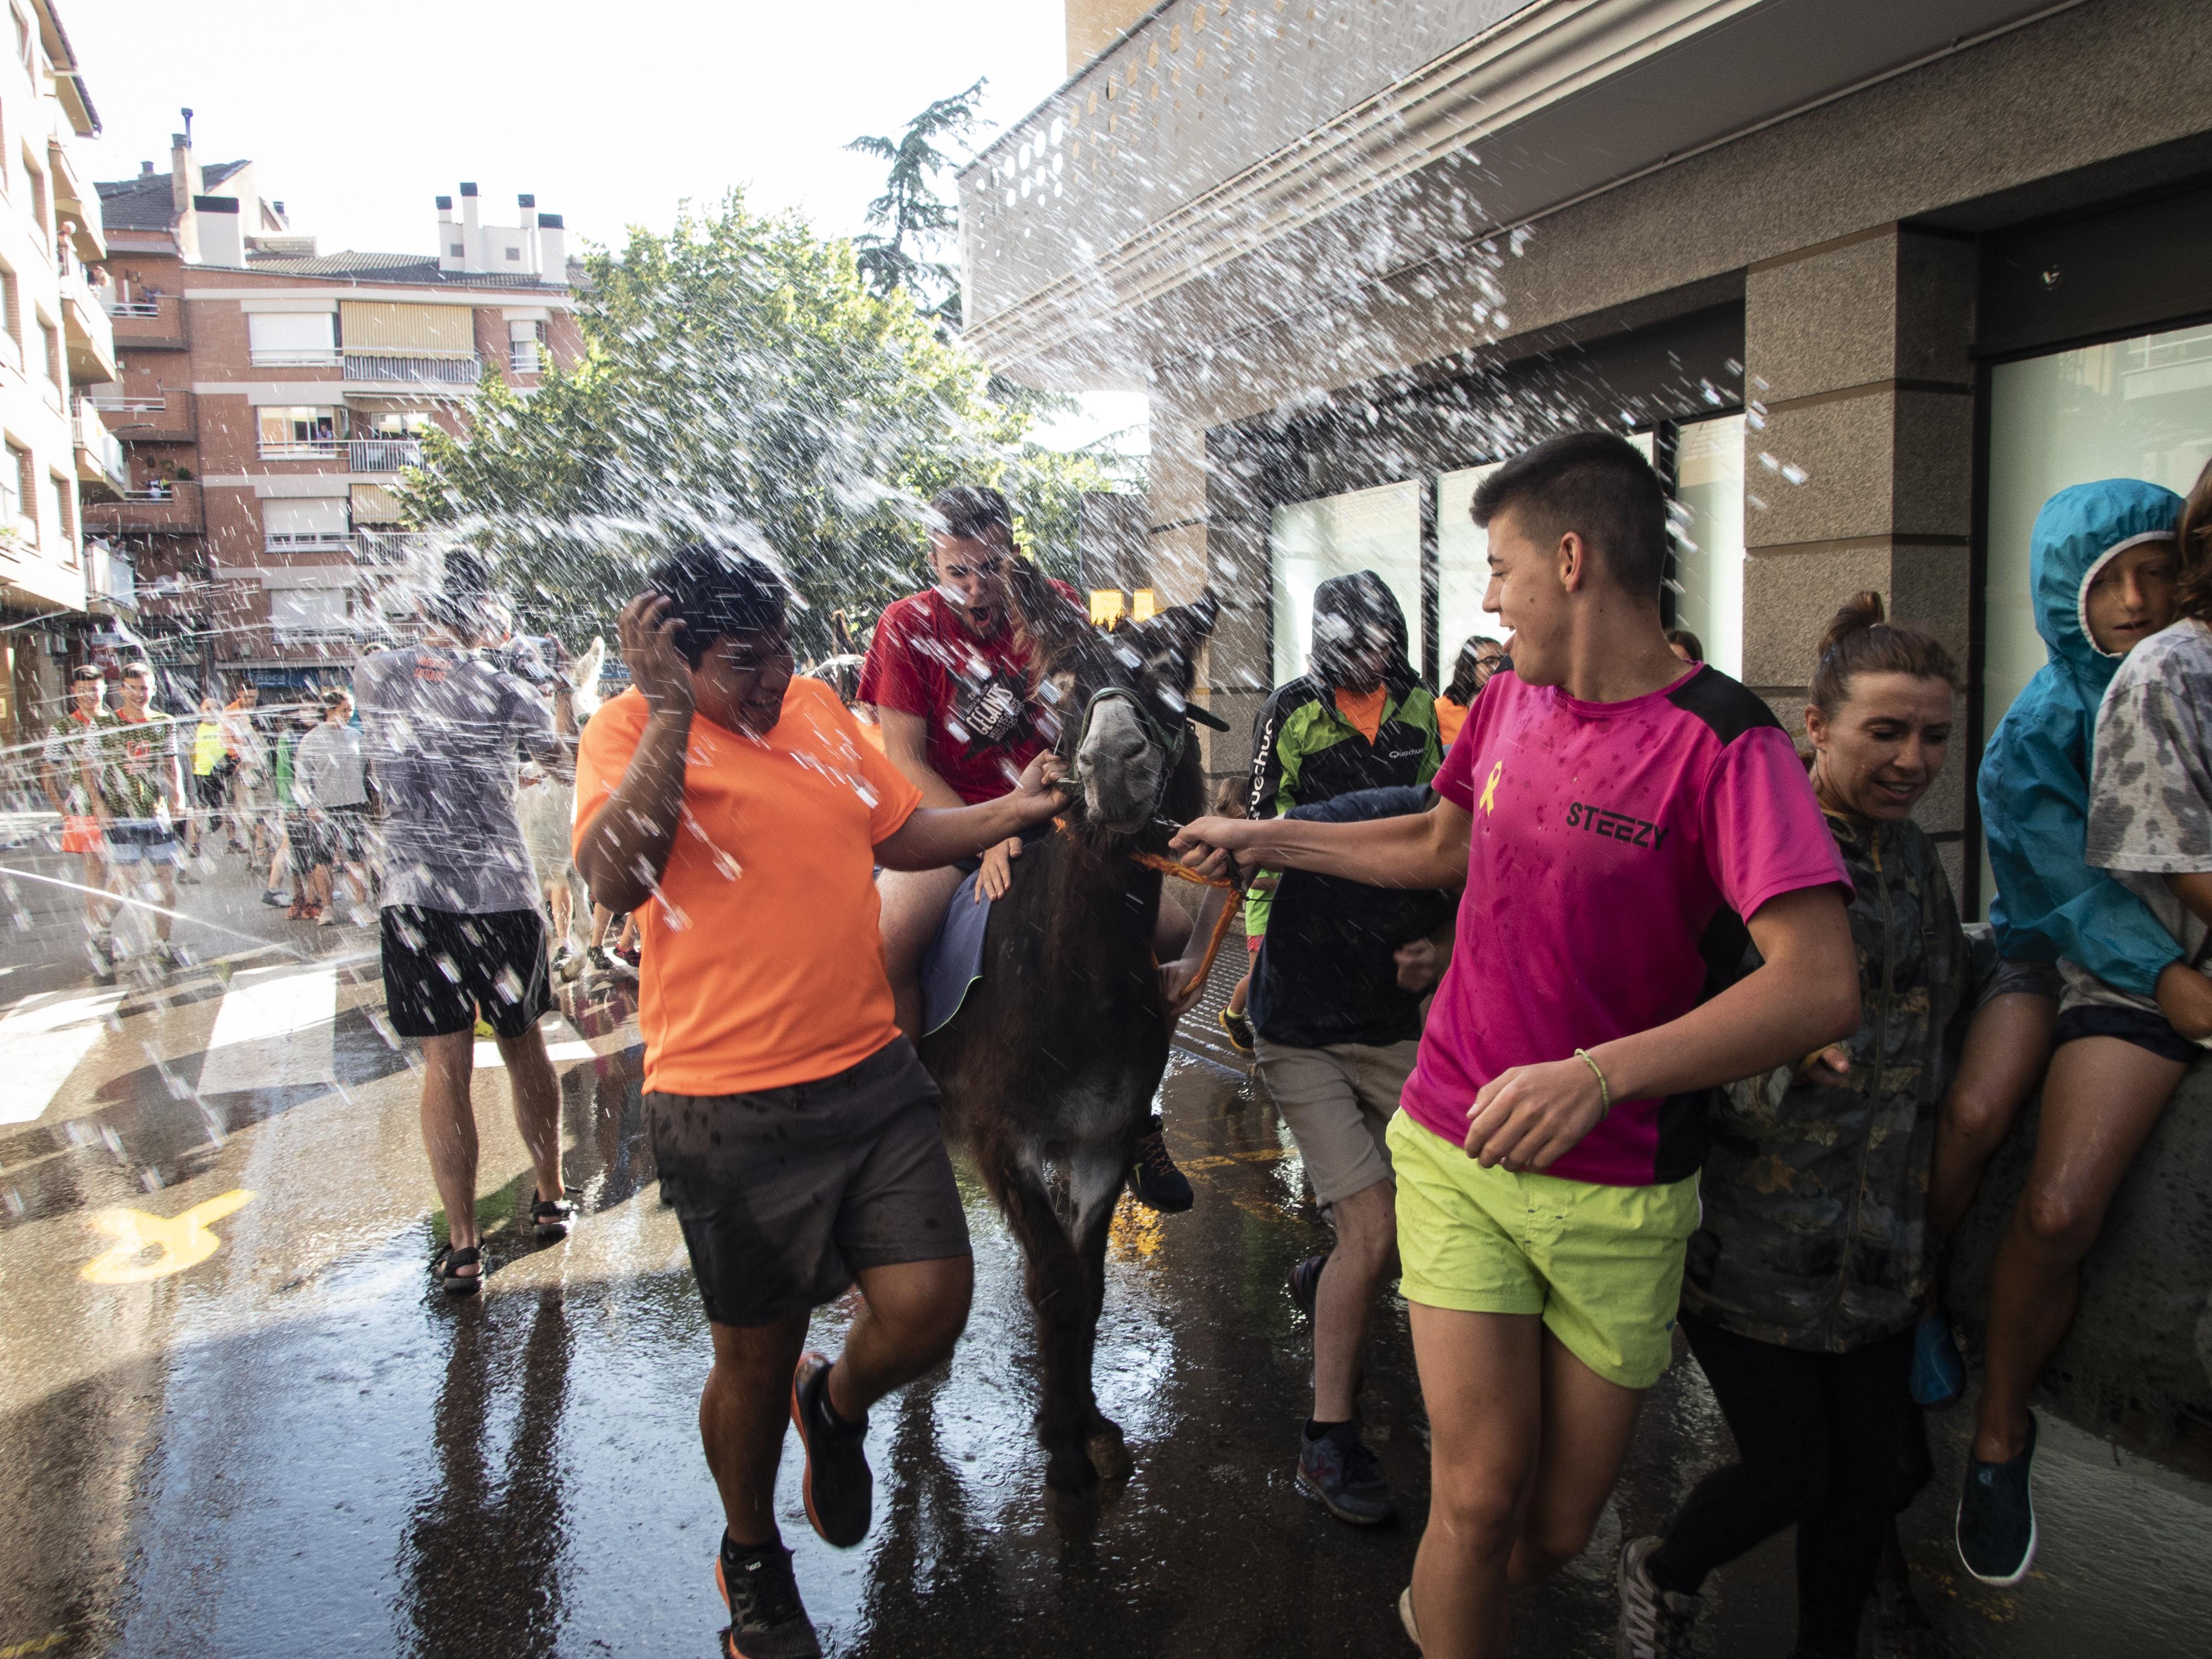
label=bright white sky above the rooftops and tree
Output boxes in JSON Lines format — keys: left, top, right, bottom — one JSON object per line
{"left": 74, "top": 0, "right": 1141, "bottom": 451}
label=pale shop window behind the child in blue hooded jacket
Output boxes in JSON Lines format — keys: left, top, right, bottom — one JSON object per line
{"left": 1982, "top": 325, "right": 2212, "bottom": 911}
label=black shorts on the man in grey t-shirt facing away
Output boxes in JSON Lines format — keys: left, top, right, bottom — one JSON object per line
{"left": 383, "top": 905, "right": 553, "bottom": 1037}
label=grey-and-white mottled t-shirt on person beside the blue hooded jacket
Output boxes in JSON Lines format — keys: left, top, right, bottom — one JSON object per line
{"left": 2059, "top": 617, "right": 2212, "bottom": 1011}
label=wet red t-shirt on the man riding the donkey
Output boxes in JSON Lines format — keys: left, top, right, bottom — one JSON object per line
{"left": 856, "top": 582, "right": 1082, "bottom": 805}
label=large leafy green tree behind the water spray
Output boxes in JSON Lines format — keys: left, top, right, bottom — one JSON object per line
{"left": 400, "top": 192, "right": 1106, "bottom": 655}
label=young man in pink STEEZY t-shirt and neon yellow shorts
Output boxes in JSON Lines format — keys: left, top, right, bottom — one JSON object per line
{"left": 1181, "top": 434, "right": 1858, "bottom": 1655}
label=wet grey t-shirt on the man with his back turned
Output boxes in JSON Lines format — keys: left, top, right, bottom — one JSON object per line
{"left": 354, "top": 646, "right": 566, "bottom": 916}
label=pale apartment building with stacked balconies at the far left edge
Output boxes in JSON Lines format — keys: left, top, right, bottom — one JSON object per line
{"left": 0, "top": 0, "right": 131, "bottom": 745}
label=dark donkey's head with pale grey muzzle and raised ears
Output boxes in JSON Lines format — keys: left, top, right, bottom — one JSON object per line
{"left": 1011, "top": 562, "right": 1225, "bottom": 836}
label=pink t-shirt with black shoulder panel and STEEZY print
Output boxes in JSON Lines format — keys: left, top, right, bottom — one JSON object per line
{"left": 1405, "top": 666, "right": 1849, "bottom": 1186}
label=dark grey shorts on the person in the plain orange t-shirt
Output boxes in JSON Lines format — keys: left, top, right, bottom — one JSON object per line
{"left": 646, "top": 1037, "right": 969, "bottom": 1325}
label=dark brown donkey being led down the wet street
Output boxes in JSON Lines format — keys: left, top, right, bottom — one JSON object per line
{"left": 920, "top": 566, "right": 1217, "bottom": 1495}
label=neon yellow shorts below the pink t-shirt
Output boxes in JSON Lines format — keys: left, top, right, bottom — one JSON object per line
{"left": 1389, "top": 1113, "right": 1699, "bottom": 1389}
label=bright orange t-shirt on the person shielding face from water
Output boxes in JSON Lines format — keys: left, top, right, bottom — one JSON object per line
{"left": 575, "top": 679, "right": 922, "bottom": 1095}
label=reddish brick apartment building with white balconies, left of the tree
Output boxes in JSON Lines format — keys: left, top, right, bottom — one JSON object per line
{"left": 91, "top": 133, "right": 580, "bottom": 688}
